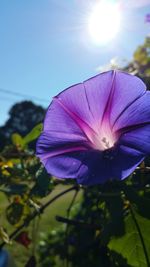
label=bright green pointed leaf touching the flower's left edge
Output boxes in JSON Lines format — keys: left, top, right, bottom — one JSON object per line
{"left": 23, "top": 123, "right": 43, "bottom": 145}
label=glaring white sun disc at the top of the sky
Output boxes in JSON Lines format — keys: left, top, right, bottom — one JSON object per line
{"left": 88, "top": 0, "right": 121, "bottom": 44}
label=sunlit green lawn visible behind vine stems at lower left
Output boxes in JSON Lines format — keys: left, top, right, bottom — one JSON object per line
{"left": 0, "top": 185, "right": 81, "bottom": 267}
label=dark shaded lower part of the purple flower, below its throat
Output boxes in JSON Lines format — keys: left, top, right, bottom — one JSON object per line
{"left": 37, "top": 133, "right": 144, "bottom": 185}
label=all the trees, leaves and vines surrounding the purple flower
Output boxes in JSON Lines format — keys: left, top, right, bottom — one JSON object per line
{"left": 0, "top": 38, "right": 150, "bottom": 267}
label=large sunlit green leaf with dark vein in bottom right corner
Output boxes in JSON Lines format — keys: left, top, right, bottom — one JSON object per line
{"left": 108, "top": 211, "right": 150, "bottom": 267}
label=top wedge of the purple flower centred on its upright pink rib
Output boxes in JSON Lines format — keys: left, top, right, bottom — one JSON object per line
{"left": 84, "top": 71, "right": 146, "bottom": 130}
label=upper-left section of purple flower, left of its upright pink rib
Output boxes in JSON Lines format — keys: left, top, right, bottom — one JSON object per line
{"left": 41, "top": 72, "right": 114, "bottom": 150}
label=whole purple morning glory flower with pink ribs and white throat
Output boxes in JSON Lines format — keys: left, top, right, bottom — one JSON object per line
{"left": 37, "top": 71, "right": 150, "bottom": 185}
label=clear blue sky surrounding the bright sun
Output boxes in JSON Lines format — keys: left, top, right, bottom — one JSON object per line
{"left": 0, "top": 0, "right": 150, "bottom": 125}
